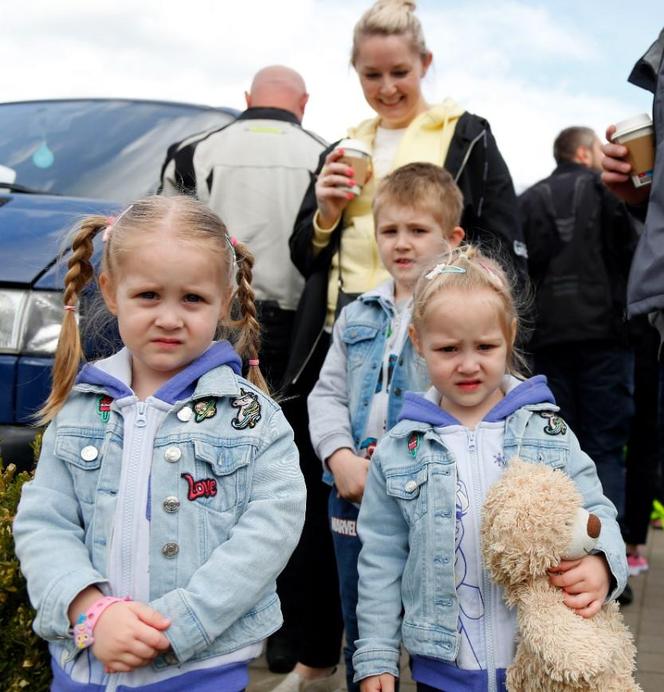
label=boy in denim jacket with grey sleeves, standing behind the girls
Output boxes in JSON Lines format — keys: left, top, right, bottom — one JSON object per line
{"left": 308, "top": 163, "right": 464, "bottom": 692}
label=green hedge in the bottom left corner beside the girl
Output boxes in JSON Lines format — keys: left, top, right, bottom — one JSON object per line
{"left": 0, "top": 454, "right": 51, "bottom": 692}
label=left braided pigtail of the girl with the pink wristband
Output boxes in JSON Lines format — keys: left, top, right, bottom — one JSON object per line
{"left": 37, "top": 216, "right": 108, "bottom": 425}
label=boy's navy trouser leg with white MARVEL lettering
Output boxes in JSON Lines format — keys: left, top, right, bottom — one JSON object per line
{"left": 329, "top": 487, "right": 362, "bottom": 692}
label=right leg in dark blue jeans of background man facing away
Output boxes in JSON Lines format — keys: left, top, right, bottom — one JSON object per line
{"left": 574, "top": 342, "right": 634, "bottom": 521}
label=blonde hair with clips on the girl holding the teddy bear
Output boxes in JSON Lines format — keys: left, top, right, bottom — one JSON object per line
{"left": 412, "top": 245, "right": 528, "bottom": 378}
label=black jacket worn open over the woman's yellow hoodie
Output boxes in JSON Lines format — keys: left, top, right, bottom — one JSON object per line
{"left": 285, "top": 112, "right": 526, "bottom": 390}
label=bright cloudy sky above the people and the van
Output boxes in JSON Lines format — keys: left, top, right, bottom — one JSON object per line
{"left": 0, "top": 0, "right": 664, "bottom": 189}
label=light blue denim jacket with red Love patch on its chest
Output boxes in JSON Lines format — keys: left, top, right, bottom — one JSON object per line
{"left": 14, "top": 344, "right": 306, "bottom": 668}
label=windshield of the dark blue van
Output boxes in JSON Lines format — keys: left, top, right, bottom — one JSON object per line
{"left": 0, "top": 99, "right": 233, "bottom": 203}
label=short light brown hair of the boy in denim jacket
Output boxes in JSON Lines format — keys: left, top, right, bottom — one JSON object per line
{"left": 372, "top": 162, "right": 463, "bottom": 235}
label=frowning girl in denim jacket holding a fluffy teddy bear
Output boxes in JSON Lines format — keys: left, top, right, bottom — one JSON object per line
{"left": 353, "top": 245, "right": 627, "bottom": 692}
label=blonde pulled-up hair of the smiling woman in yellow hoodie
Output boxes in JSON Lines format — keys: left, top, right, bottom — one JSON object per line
{"left": 350, "top": 0, "right": 429, "bottom": 66}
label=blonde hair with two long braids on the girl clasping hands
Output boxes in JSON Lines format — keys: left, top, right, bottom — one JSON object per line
{"left": 37, "top": 195, "right": 269, "bottom": 424}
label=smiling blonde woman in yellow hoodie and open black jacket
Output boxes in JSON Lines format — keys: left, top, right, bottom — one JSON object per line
{"left": 285, "top": 0, "right": 525, "bottom": 391}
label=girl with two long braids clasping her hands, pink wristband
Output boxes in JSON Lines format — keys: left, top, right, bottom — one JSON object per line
{"left": 14, "top": 197, "right": 305, "bottom": 692}
